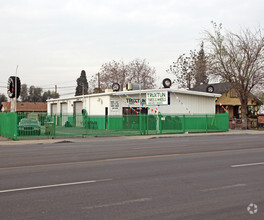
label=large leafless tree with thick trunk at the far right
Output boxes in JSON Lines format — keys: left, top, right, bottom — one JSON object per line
{"left": 205, "top": 22, "right": 264, "bottom": 129}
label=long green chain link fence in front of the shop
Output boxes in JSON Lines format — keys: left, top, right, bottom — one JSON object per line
{"left": 0, "top": 113, "right": 229, "bottom": 140}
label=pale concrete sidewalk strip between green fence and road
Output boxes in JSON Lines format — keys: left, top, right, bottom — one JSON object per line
{"left": 0, "top": 130, "right": 264, "bottom": 146}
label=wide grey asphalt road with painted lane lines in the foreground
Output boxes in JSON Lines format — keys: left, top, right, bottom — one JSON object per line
{"left": 0, "top": 135, "right": 264, "bottom": 220}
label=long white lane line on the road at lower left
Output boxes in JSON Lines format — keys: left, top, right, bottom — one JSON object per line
{"left": 0, "top": 179, "right": 112, "bottom": 193}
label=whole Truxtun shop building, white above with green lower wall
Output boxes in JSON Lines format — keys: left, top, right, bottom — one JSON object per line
{"left": 47, "top": 88, "right": 228, "bottom": 134}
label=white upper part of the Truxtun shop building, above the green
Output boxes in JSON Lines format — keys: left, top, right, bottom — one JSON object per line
{"left": 47, "top": 89, "right": 221, "bottom": 116}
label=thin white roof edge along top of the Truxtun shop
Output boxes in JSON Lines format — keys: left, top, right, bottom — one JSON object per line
{"left": 47, "top": 88, "right": 221, "bottom": 102}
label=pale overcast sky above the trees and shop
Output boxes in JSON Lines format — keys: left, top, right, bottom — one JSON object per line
{"left": 0, "top": 0, "right": 264, "bottom": 94}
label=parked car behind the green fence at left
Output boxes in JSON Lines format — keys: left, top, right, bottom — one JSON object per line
{"left": 18, "top": 118, "right": 41, "bottom": 135}
